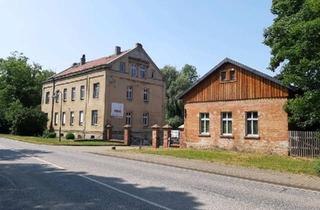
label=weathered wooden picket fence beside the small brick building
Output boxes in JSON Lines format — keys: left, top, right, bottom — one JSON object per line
{"left": 289, "top": 131, "right": 320, "bottom": 158}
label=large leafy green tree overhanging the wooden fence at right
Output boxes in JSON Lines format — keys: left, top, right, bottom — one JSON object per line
{"left": 264, "top": 0, "right": 320, "bottom": 129}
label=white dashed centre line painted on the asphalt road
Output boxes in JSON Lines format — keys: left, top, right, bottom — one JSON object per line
{"left": 15, "top": 148, "right": 172, "bottom": 210}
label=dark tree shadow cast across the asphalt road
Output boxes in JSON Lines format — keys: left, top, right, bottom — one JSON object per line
{"left": 0, "top": 150, "right": 202, "bottom": 210}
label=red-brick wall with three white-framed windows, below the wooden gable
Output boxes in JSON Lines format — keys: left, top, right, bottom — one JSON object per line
{"left": 184, "top": 98, "right": 288, "bottom": 154}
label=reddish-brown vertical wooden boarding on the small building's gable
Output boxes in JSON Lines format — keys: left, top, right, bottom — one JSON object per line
{"left": 183, "top": 63, "right": 288, "bottom": 103}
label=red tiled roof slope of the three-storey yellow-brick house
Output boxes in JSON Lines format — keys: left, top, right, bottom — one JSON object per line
{"left": 53, "top": 50, "right": 130, "bottom": 78}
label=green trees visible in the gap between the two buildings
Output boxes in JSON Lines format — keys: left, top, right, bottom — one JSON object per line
{"left": 161, "top": 64, "right": 199, "bottom": 128}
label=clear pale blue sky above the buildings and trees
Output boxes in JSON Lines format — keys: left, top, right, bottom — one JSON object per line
{"left": 0, "top": 0, "right": 273, "bottom": 75}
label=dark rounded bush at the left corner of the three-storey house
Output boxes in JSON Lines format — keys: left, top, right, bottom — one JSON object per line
{"left": 11, "top": 107, "right": 48, "bottom": 136}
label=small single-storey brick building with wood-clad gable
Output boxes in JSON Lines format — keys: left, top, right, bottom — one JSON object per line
{"left": 180, "top": 58, "right": 291, "bottom": 154}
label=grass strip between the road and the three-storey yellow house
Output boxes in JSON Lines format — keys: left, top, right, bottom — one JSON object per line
{"left": 0, "top": 134, "right": 123, "bottom": 146}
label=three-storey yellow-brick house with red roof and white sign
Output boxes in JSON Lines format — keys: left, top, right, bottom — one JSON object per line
{"left": 41, "top": 43, "right": 165, "bottom": 139}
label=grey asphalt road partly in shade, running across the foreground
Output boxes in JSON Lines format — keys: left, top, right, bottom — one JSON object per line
{"left": 0, "top": 139, "right": 320, "bottom": 210}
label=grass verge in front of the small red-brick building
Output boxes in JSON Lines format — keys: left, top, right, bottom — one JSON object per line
{"left": 128, "top": 148, "right": 319, "bottom": 175}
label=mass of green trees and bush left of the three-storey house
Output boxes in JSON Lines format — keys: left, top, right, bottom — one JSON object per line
{"left": 0, "top": 52, "right": 54, "bottom": 135}
